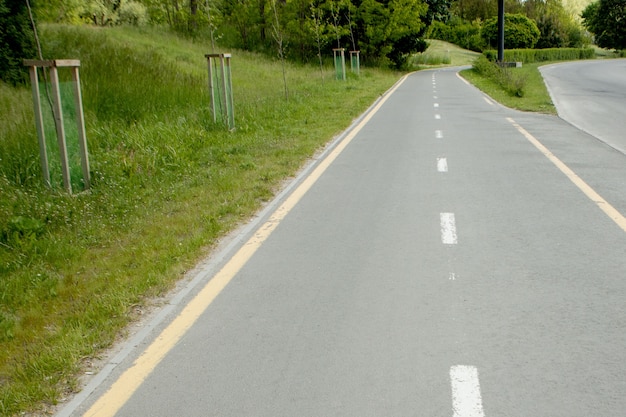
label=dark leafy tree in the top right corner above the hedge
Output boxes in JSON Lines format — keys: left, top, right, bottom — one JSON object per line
{"left": 582, "top": 0, "right": 626, "bottom": 49}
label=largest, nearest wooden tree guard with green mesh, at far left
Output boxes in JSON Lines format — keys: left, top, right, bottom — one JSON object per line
{"left": 24, "top": 59, "right": 91, "bottom": 194}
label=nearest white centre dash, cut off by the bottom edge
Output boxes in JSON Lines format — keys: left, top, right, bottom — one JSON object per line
{"left": 450, "top": 365, "right": 485, "bottom": 417}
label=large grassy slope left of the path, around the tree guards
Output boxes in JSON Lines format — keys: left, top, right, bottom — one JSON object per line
{"left": 0, "top": 26, "right": 398, "bottom": 415}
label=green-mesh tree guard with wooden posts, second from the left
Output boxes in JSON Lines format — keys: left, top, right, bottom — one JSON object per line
{"left": 205, "top": 54, "right": 235, "bottom": 130}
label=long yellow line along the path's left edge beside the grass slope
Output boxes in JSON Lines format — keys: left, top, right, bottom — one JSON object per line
{"left": 84, "top": 76, "right": 407, "bottom": 417}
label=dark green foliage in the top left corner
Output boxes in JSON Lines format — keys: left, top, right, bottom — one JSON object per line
{"left": 0, "top": 0, "right": 37, "bottom": 85}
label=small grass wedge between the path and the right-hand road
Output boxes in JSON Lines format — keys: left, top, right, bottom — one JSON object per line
{"left": 461, "top": 62, "right": 556, "bottom": 114}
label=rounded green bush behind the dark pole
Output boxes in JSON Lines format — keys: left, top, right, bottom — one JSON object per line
{"left": 481, "top": 13, "right": 541, "bottom": 48}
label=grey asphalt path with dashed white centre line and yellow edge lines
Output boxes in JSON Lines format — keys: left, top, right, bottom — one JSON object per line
{"left": 59, "top": 69, "right": 626, "bottom": 417}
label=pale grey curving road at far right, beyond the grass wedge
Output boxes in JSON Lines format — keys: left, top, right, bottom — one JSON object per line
{"left": 540, "top": 59, "right": 626, "bottom": 153}
